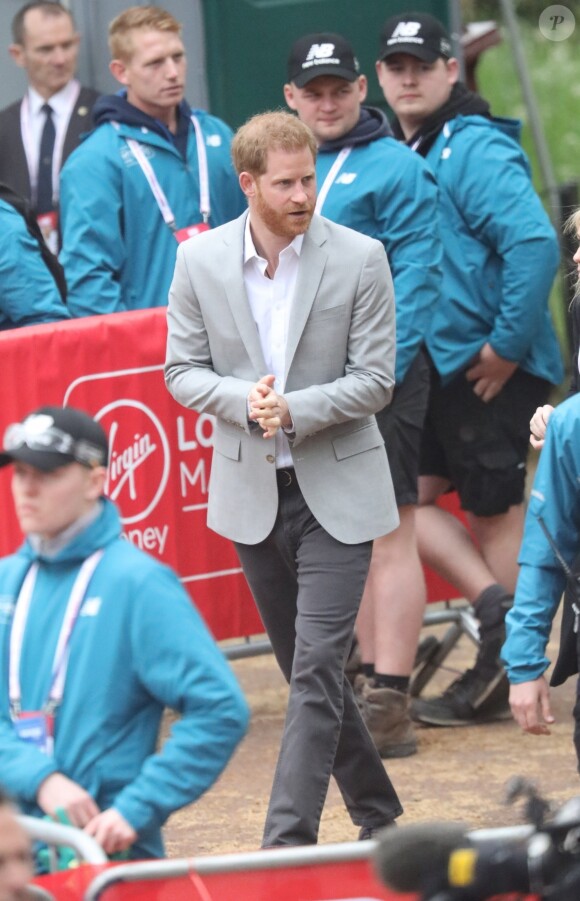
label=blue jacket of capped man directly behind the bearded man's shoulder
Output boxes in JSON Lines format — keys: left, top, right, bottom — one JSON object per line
{"left": 316, "top": 107, "right": 442, "bottom": 383}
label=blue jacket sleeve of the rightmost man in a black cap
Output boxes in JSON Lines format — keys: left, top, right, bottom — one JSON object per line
{"left": 451, "top": 128, "right": 559, "bottom": 363}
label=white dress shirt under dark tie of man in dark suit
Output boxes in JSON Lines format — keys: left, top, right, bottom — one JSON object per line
{"left": 20, "top": 78, "right": 81, "bottom": 201}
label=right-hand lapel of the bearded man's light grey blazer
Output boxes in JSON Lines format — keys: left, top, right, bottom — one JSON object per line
{"left": 286, "top": 215, "right": 328, "bottom": 378}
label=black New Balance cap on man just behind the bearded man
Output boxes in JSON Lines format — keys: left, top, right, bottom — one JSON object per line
{"left": 288, "top": 31, "right": 360, "bottom": 88}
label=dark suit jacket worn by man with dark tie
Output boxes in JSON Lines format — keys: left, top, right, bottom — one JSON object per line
{"left": 0, "top": 88, "right": 99, "bottom": 200}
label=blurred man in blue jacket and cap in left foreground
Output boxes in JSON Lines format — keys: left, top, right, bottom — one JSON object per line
{"left": 0, "top": 406, "right": 248, "bottom": 858}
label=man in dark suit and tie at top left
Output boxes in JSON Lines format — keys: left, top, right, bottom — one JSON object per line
{"left": 0, "top": 0, "right": 98, "bottom": 250}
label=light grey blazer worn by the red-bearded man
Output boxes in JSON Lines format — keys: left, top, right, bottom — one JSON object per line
{"left": 165, "top": 214, "right": 398, "bottom": 544}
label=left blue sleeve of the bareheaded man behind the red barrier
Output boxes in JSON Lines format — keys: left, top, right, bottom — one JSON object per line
{"left": 60, "top": 135, "right": 125, "bottom": 316}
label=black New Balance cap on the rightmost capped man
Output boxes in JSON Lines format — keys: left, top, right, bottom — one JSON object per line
{"left": 379, "top": 13, "right": 453, "bottom": 63}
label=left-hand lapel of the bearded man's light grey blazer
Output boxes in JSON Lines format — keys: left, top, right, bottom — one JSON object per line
{"left": 222, "top": 213, "right": 266, "bottom": 375}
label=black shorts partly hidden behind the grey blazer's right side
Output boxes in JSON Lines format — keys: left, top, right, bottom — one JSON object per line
{"left": 376, "top": 351, "right": 429, "bottom": 507}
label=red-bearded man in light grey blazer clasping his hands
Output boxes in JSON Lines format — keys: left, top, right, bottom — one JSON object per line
{"left": 165, "top": 112, "right": 402, "bottom": 847}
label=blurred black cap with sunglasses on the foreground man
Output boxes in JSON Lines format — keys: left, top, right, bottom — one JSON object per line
{"left": 0, "top": 407, "right": 109, "bottom": 472}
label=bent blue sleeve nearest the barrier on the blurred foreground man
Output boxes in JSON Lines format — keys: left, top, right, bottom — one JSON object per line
{"left": 114, "top": 567, "right": 248, "bottom": 832}
